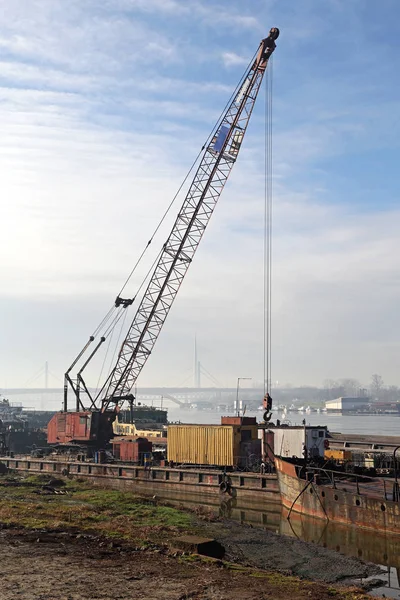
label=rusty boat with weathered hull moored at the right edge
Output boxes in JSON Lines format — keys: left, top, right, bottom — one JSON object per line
{"left": 275, "top": 457, "right": 400, "bottom": 534}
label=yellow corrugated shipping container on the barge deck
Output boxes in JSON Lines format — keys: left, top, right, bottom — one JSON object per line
{"left": 168, "top": 425, "right": 257, "bottom": 467}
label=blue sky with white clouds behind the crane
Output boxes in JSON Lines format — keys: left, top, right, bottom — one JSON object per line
{"left": 0, "top": 0, "right": 400, "bottom": 392}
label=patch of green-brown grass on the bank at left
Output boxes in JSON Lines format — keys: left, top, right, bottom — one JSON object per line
{"left": 0, "top": 475, "right": 193, "bottom": 542}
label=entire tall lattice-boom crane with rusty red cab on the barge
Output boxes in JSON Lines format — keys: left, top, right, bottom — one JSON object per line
{"left": 48, "top": 27, "right": 279, "bottom": 448}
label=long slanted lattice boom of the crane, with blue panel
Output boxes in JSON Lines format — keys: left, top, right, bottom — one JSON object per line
{"left": 96, "top": 28, "right": 279, "bottom": 411}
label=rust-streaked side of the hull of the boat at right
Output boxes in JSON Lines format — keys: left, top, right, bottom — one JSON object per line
{"left": 275, "top": 458, "right": 400, "bottom": 534}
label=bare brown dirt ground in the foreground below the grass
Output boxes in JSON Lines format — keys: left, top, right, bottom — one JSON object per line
{"left": 0, "top": 529, "right": 378, "bottom": 600}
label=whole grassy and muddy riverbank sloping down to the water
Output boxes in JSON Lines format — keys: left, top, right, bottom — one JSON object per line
{"left": 0, "top": 476, "right": 377, "bottom": 600}
